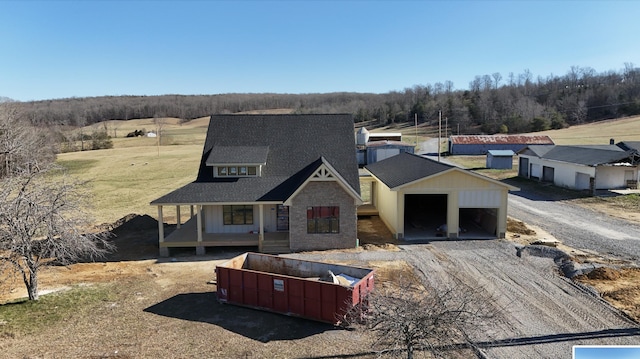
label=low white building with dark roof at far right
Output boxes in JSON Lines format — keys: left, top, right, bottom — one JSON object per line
{"left": 518, "top": 145, "right": 640, "bottom": 191}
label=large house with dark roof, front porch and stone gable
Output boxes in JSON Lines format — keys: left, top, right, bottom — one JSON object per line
{"left": 151, "top": 115, "right": 362, "bottom": 256}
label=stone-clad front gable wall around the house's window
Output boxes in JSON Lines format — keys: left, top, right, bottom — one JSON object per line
{"left": 289, "top": 181, "right": 358, "bottom": 252}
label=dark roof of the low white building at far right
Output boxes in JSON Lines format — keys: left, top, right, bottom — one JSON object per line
{"left": 519, "top": 145, "right": 633, "bottom": 166}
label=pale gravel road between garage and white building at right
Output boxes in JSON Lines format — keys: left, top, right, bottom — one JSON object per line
{"left": 508, "top": 184, "right": 640, "bottom": 265}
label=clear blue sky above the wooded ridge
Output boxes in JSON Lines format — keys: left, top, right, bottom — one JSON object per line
{"left": 0, "top": 0, "right": 640, "bottom": 101}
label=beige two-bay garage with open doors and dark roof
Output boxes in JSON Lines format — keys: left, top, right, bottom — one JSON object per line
{"left": 361, "top": 153, "right": 519, "bottom": 240}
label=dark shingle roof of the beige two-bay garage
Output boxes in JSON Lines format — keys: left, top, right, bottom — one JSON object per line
{"left": 365, "top": 153, "right": 454, "bottom": 188}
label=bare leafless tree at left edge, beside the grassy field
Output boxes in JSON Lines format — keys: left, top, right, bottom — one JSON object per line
{"left": 0, "top": 169, "right": 112, "bottom": 300}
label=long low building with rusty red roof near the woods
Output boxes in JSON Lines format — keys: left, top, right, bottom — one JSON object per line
{"left": 449, "top": 135, "right": 554, "bottom": 155}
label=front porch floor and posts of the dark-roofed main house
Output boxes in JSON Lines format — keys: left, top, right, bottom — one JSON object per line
{"left": 158, "top": 205, "right": 290, "bottom": 257}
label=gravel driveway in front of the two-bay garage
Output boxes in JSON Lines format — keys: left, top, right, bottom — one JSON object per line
{"left": 288, "top": 240, "right": 640, "bottom": 358}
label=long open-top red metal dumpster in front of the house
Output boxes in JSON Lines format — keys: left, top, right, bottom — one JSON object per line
{"left": 216, "top": 253, "right": 374, "bottom": 324}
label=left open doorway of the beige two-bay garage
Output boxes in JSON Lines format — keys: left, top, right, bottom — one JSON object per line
{"left": 404, "top": 194, "right": 447, "bottom": 240}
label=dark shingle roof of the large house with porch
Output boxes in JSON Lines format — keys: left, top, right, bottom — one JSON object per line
{"left": 151, "top": 114, "right": 360, "bottom": 205}
